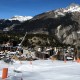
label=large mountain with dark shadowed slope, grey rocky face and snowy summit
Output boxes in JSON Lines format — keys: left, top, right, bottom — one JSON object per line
{"left": 0, "top": 3, "right": 80, "bottom": 46}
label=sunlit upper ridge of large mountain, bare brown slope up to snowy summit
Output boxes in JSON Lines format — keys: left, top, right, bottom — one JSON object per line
{"left": 32, "top": 3, "right": 80, "bottom": 20}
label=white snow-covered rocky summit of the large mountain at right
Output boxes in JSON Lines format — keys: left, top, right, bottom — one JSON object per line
{"left": 54, "top": 3, "right": 80, "bottom": 18}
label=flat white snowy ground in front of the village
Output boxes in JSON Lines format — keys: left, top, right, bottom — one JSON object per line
{"left": 0, "top": 60, "right": 80, "bottom": 80}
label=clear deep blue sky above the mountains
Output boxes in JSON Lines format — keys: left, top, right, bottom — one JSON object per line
{"left": 0, "top": 0, "right": 80, "bottom": 18}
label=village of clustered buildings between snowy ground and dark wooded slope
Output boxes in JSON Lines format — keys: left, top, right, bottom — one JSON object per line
{"left": 0, "top": 39, "right": 80, "bottom": 63}
